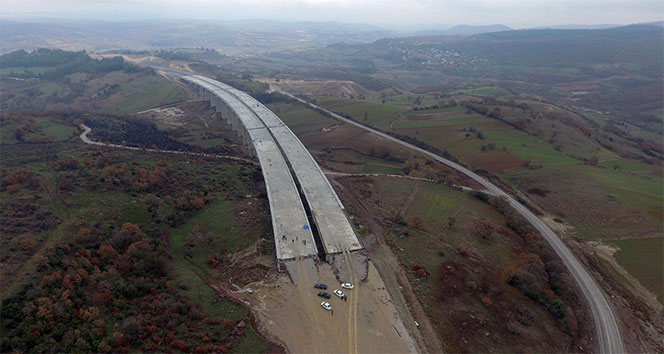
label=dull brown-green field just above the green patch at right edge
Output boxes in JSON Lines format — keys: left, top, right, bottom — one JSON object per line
{"left": 502, "top": 164, "right": 664, "bottom": 240}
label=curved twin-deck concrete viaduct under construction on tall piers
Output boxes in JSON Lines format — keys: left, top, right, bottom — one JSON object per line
{"left": 166, "top": 68, "right": 363, "bottom": 261}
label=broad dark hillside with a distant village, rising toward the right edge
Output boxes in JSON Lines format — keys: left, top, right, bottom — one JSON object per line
{"left": 269, "top": 24, "right": 664, "bottom": 131}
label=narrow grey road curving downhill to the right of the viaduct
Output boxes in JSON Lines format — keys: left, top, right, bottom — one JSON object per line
{"left": 276, "top": 90, "right": 624, "bottom": 353}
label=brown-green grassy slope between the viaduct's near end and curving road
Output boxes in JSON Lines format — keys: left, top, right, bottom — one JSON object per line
{"left": 373, "top": 178, "right": 560, "bottom": 352}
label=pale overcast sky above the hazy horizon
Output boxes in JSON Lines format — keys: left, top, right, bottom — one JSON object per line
{"left": 0, "top": 0, "right": 664, "bottom": 28}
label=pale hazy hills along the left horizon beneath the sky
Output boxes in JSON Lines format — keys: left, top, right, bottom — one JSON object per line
{"left": 0, "top": 20, "right": 393, "bottom": 52}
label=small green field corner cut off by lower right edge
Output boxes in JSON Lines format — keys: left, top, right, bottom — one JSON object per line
{"left": 607, "top": 237, "right": 664, "bottom": 303}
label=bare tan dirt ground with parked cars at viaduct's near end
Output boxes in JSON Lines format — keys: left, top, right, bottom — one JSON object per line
{"left": 233, "top": 252, "right": 420, "bottom": 353}
